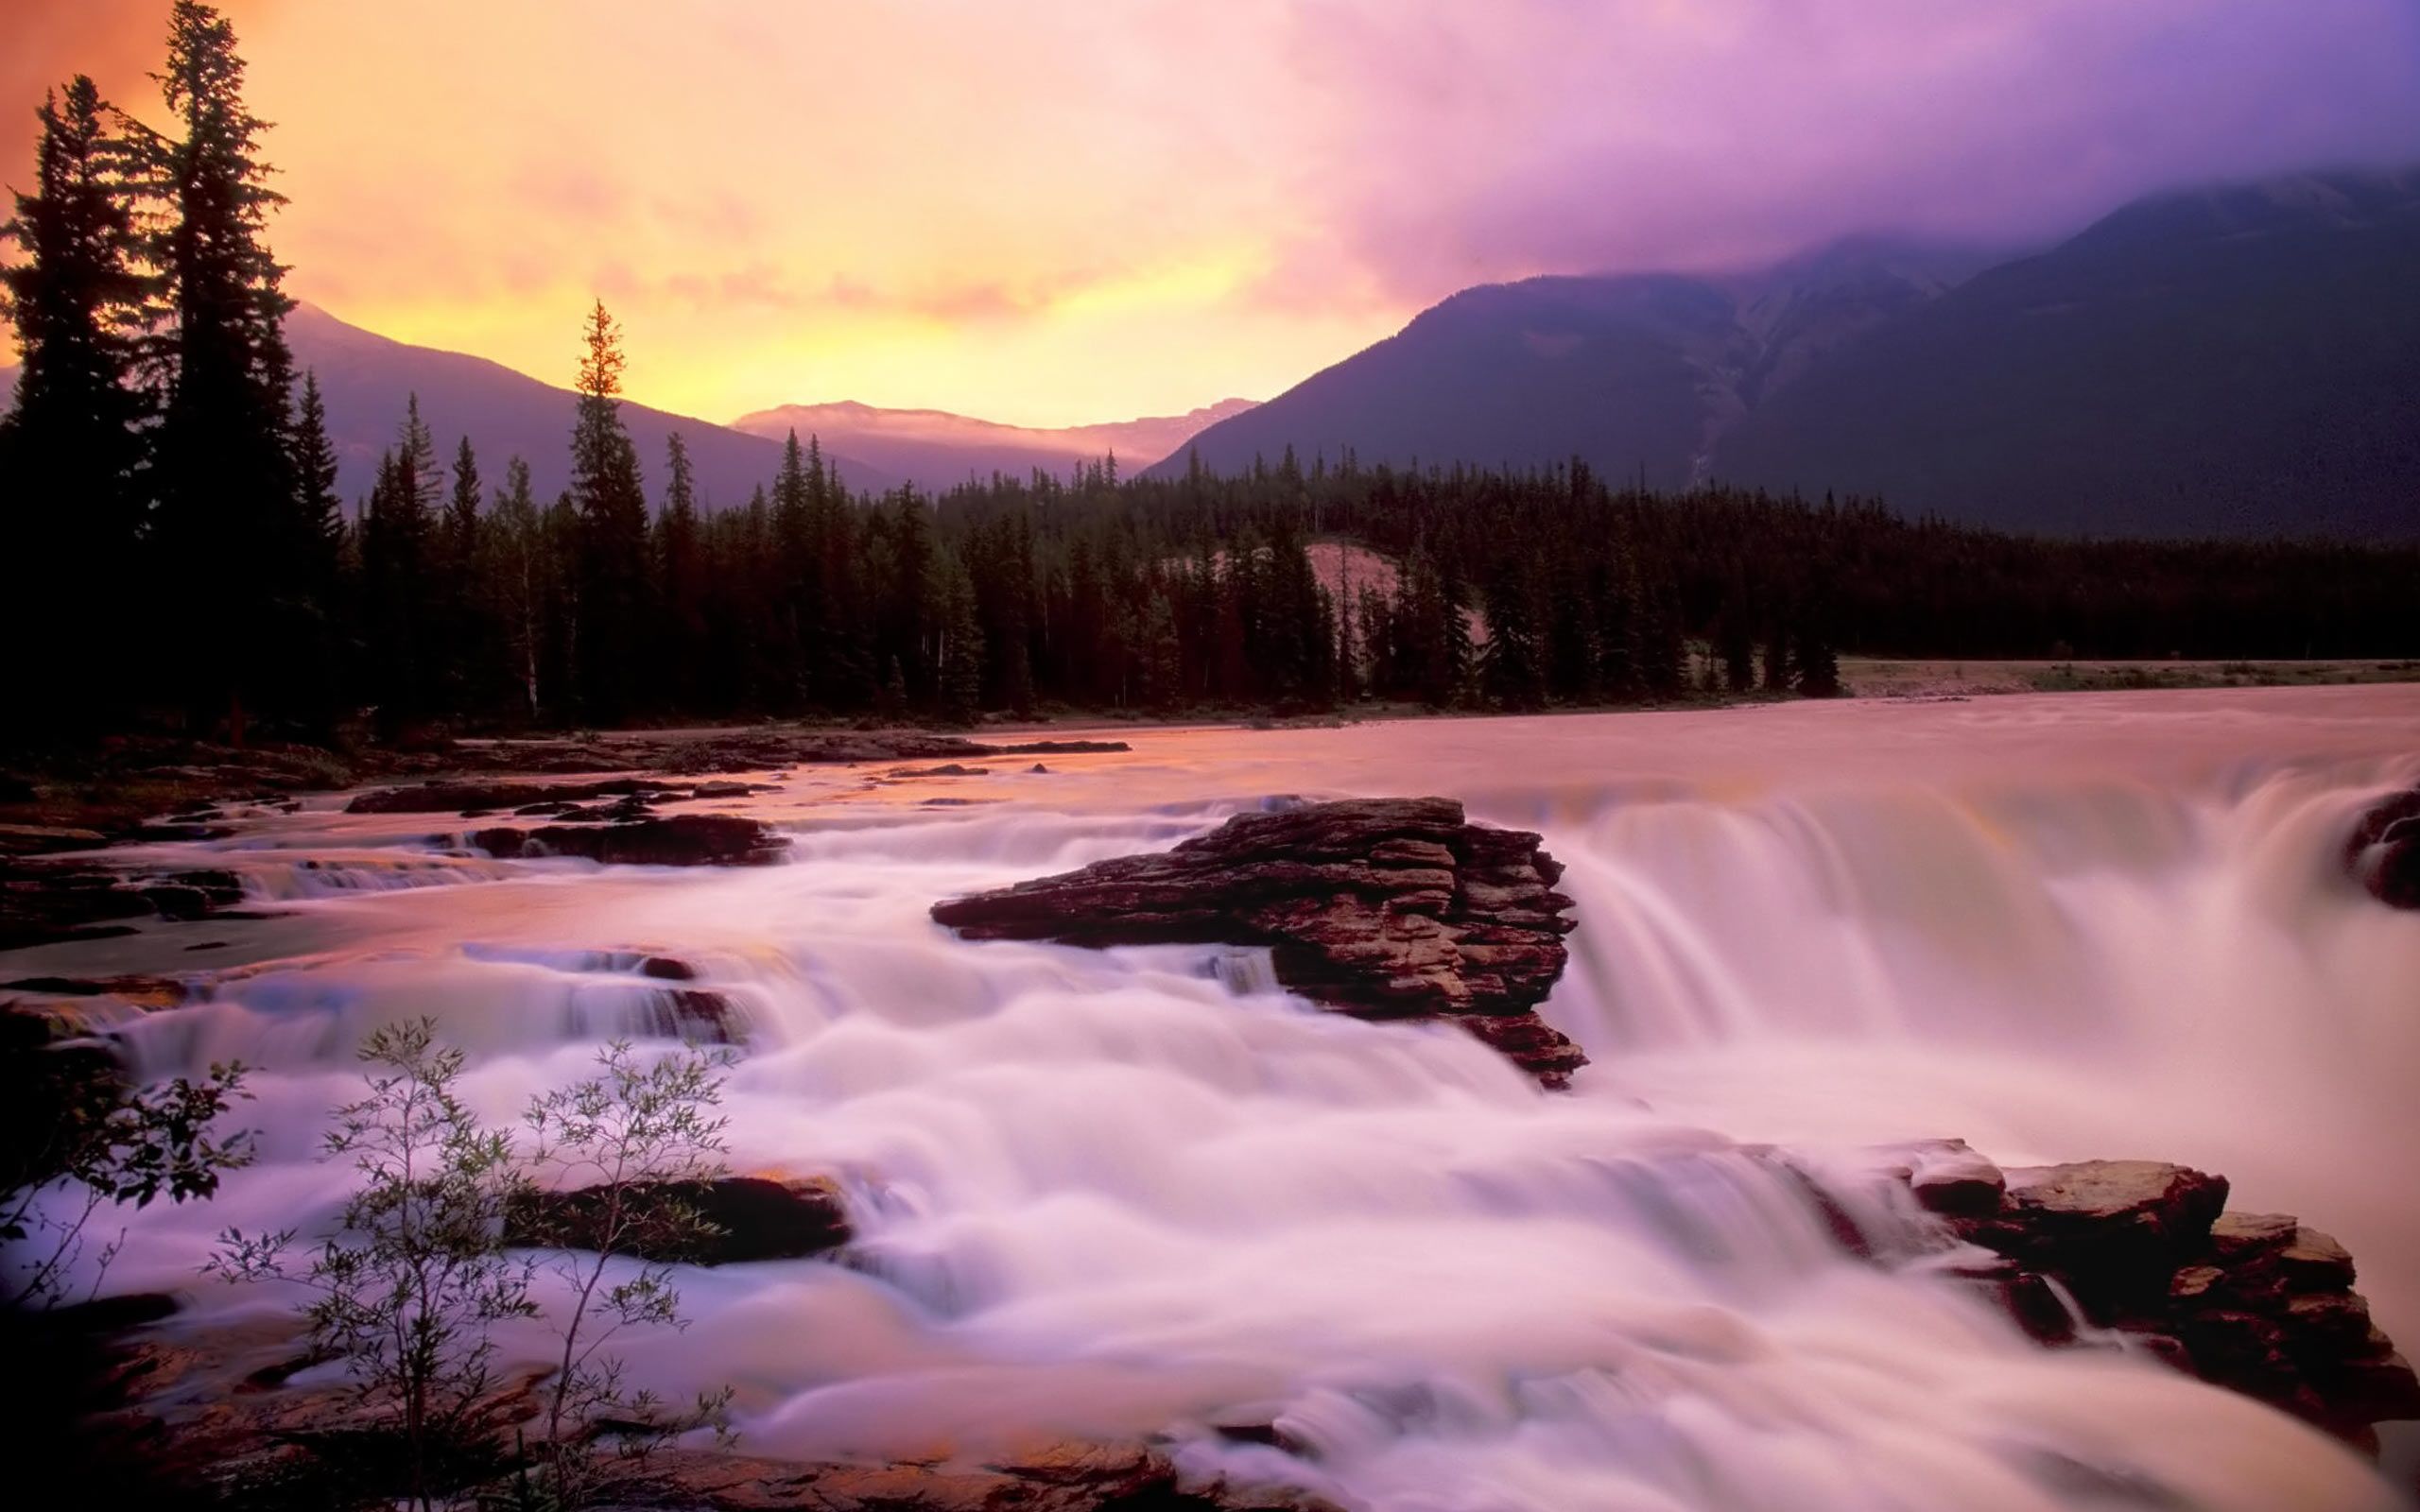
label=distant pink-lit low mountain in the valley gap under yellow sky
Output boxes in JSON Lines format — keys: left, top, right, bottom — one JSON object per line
{"left": 731, "top": 399, "right": 1253, "bottom": 489}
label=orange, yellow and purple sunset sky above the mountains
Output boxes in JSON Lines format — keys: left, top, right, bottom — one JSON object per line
{"left": 0, "top": 0, "right": 2420, "bottom": 423}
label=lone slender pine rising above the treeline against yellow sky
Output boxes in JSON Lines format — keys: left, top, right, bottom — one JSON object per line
{"left": 571, "top": 300, "right": 651, "bottom": 723}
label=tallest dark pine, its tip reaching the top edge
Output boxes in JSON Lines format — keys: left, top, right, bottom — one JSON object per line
{"left": 150, "top": 0, "right": 305, "bottom": 738}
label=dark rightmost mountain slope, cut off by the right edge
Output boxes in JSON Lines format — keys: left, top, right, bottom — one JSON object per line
{"left": 1719, "top": 172, "right": 2420, "bottom": 537}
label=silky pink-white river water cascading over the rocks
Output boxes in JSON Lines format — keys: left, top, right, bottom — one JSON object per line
{"left": 5, "top": 687, "right": 2420, "bottom": 1512}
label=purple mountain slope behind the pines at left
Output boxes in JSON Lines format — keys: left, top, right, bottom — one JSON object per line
{"left": 285, "top": 305, "right": 898, "bottom": 506}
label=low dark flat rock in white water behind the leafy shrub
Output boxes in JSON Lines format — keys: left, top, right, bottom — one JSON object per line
{"left": 506, "top": 1176, "right": 850, "bottom": 1265}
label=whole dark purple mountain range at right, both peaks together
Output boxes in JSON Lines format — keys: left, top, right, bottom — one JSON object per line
{"left": 1152, "top": 172, "right": 2420, "bottom": 537}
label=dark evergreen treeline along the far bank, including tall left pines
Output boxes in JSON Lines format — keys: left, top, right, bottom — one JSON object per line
{"left": 0, "top": 0, "right": 2420, "bottom": 735}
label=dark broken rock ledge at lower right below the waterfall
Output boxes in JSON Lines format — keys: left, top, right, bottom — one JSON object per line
{"left": 1907, "top": 1142, "right": 2420, "bottom": 1447}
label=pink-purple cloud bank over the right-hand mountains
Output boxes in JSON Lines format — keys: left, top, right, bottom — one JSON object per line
{"left": 1289, "top": 0, "right": 2420, "bottom": 298}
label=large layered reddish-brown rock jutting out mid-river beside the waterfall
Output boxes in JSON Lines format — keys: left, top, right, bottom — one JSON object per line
{"left": 932, "top": 799, "right": 1587, "bottom": 1086}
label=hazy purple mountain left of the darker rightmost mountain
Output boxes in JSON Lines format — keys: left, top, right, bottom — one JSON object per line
{"left": 1152, "top": 239, "right": 1992, "bottom": 489}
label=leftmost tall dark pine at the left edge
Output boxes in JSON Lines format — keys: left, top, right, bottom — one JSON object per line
{"left": 0, "top": 75, "right": 147, "bottom": 726}
